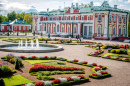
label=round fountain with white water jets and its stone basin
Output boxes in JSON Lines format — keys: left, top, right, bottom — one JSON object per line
{"left": 0, "top": 39, "right": 63, "bottom": 53}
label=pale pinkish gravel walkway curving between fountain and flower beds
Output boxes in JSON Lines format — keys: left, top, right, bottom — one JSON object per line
{"left": 0, "top": 37, "right": 130, "bottom": 86}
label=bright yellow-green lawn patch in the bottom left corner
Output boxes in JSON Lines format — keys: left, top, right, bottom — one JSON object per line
{"left": 4, "top": 75, "right": 33, "bottom": 86}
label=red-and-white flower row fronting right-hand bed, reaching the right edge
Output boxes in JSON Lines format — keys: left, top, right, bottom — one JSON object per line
{"left": 102, "top": 55, "right": 130, "bottom": 62}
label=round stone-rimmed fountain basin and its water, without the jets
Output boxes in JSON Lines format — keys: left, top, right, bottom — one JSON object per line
{"left": 0, "top": 44, "right": 63, "bottom": 53}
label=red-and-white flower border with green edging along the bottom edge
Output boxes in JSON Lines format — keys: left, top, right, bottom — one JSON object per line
{"left": 21, "top": 75, "right": 89, "bottom": 86}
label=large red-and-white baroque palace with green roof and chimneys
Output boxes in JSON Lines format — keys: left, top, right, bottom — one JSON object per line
{"left": 33, "top": 1, "right": 129, "bottom": 39}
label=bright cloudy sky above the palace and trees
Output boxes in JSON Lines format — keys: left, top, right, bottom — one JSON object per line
{"left": 0, "top": 0, "right": 130, "bottom": 16}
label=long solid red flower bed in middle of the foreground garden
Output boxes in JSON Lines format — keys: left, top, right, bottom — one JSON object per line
{"left": 29, "top": 64, "right": 83, "bottom": 72}
